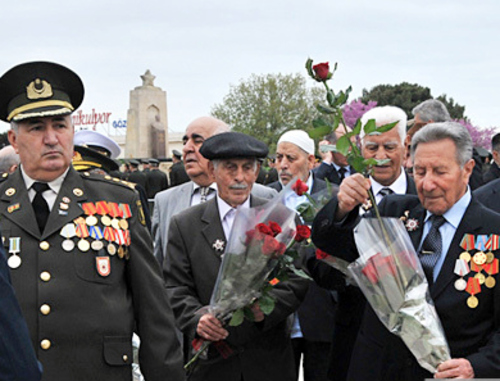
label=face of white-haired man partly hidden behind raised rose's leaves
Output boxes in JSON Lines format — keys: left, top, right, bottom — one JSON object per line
{"left": 362, "top": 127, "right": 405, "bottom": 186}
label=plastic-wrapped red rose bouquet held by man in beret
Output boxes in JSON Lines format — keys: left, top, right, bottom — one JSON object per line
{"left": 185, "top": 191, "right": 310, "bottom": 370}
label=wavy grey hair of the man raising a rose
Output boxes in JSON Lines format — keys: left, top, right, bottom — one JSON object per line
{"left": 411, "top": 122, "right": 473, "bottom": 168}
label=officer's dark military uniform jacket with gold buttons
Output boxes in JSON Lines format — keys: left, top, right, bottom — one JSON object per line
{"left": 0, "top": 168, "right": 184, "bottom": 381}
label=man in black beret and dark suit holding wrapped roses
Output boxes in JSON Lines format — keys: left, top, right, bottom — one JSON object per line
{"left": 164, "top": 132, "right": 308, "bottom": 381}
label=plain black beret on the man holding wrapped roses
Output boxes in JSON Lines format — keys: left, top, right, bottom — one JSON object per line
{"left": 200, "top": 132, "right": 269, "bottom": 160}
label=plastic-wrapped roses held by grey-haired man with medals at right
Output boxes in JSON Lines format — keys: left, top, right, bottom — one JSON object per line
{"left": 348, "top": 217, "right": 450, "bottom": 373}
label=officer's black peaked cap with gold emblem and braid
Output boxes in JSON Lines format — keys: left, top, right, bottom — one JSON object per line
{"left": 0, "top": 62, "right": 84, "bottom": 122}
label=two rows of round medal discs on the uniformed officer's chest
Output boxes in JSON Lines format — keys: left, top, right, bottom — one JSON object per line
{"left": 61, "top": 215, "right": 129, "bottom": 258}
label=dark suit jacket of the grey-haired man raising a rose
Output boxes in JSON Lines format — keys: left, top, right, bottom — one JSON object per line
{"left": 313, "top": 195, "right": 500, "bottom": 381}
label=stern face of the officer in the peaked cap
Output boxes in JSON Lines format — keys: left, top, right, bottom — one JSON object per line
{"left": 9, "top": 115, "right": 74, "bottom": 182}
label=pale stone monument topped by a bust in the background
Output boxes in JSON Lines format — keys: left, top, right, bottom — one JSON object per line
{"left": 125, "top": 70, "right": 169, "bottom": 158}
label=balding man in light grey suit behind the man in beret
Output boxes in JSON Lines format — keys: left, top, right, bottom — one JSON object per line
{"left": 152, "top": 116, "right": 276, "bottom": 264}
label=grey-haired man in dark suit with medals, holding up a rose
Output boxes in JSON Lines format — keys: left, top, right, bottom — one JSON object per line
{"left": 313, "top": 122, "right": 500, "bottom": 381}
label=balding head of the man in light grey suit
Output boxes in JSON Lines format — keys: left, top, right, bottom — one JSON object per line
{"left": 182, "top": 116, "right": 230, "bottom": 186}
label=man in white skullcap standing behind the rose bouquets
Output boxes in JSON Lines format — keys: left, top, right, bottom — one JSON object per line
{"left": 269, "top": 130, "right": 335, "bottom": 381}
